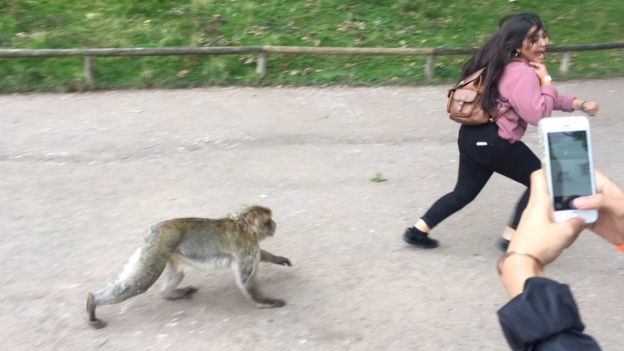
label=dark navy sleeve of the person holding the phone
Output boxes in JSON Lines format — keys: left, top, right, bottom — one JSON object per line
{"left": 498, "top": 277, "right": 600, "bottom": 351}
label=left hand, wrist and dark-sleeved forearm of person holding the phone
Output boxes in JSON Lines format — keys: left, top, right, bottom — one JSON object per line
{"left": 498, "top": 170, "right": 600, "bottom": 351}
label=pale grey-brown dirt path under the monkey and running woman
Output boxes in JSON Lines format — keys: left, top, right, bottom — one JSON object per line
{"left": 0, "top": 78, "right": 624, "bottom": 350}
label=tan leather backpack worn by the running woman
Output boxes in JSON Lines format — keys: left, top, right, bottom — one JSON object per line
{"left": 446, "top": 68, "right": 509, "bottom": 126}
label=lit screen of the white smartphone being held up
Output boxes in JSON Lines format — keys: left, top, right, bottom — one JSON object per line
{"left": 548, "top": 130, "right": 592, "bottom": 211}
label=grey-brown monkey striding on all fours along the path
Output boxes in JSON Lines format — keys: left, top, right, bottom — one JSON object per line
{"left": 86, "top": 205, "right": 292, "bottom": 329}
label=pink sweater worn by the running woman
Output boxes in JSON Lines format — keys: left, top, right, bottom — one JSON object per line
{"left": 496, "top": 60, "right": 576, "bottom": 143}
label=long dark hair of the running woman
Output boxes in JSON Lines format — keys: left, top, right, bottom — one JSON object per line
{"left": 462, "top": 13, "right": 546, "bottom": 111}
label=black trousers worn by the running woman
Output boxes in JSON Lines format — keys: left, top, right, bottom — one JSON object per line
{"left": 422, "top": 123, "right": 541, "bottom": 229}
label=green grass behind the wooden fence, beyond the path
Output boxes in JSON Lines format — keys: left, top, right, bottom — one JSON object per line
{"left": 0, "top": 0, "right": 624, "bottom": 93}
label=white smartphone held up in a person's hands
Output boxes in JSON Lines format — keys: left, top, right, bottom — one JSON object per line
{"left": 538, "top": 116, "right": 598, "bottom": 223}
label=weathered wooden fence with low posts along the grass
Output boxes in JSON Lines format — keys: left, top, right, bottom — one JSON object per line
{"left": 0, "top": 42, "right": 624, "bottom": 86}
